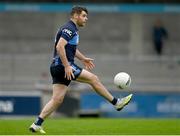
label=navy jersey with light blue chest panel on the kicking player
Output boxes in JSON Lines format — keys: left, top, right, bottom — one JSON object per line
{"left": 53, "top": 21, "right": 79, "bottom": 65}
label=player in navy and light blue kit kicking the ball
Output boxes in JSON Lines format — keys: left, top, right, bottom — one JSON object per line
{"left": 30, "top": 6, "right": 132, "bottom": 133}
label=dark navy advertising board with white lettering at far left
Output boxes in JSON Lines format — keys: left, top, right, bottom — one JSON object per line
{"left": 0, "top": 96, "right": 41, "bottom": 115}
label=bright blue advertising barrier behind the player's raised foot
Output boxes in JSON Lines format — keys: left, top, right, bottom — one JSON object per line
{"left": 80, "top": 92, "right": 180, "bottom": 117}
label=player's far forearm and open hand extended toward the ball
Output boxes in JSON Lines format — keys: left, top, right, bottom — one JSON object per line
{"left": 75, "top": 49, "right": 95, "bottom": 70}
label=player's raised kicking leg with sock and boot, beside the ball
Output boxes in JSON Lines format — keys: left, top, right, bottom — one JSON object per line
{"left": 76, "top": 69, "right": 132, "bottom": 111}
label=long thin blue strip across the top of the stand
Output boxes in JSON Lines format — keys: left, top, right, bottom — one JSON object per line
{"left": 0, "top": 3, "right": 180, "bottom": 13}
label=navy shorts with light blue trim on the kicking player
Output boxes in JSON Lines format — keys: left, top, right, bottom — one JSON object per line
{"left": 50, "top": 63, "right": 82, "bottom": 86}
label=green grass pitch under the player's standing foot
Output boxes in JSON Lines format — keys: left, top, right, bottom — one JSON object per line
{"left": 0, "top": 118, "right": 180, "bottom": 135}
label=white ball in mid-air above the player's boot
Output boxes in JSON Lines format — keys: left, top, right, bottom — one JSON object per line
{"left": 114, "top": 72, "right": 131, "bottom": 89}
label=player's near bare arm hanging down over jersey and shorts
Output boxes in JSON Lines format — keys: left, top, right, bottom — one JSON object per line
{"left": 56, "top": 37, "right": 74, "bottom": 80}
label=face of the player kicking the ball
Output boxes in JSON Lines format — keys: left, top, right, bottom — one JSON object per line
{"left": 77, "top": 11, "right": 88, "bottom": 27}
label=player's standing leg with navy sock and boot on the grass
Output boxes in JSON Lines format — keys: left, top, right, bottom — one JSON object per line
{"left": 29, "top": 84, "right": 67, "bottom": 133}
